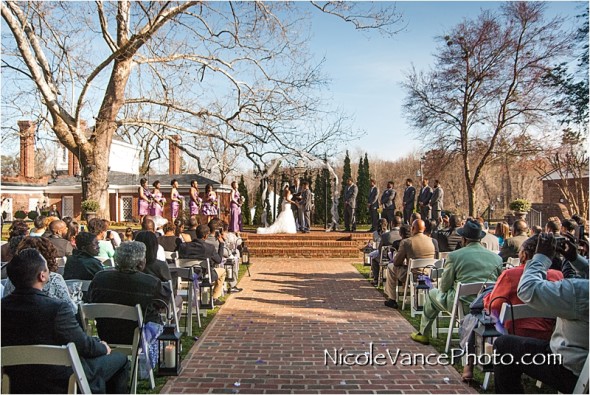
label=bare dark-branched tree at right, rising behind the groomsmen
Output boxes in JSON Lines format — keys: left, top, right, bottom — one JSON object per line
{"left": 404, "top": 2, "right": 573, "bottom": 215}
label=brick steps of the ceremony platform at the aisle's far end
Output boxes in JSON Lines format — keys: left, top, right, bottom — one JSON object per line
{"left": 241, "top": 229, "right": 372, "bottom": 262}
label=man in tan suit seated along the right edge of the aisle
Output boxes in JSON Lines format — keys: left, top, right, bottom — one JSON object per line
{"left": 385, "top": 219, "right": 435, "bottom": 309}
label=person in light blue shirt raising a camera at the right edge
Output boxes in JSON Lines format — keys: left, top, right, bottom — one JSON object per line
{"left": 494, "top": 233, "right": 588, "bottom": 394}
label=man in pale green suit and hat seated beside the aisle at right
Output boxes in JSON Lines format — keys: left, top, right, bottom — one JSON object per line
{"left": 411, "top": 220, "right": 502, "bottom": 344}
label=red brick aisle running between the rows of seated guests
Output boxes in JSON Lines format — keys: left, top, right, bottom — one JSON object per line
{"left": 162, "top": 258, "right": 474, "bottom": 394}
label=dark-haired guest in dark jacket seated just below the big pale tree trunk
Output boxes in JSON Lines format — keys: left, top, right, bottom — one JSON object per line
{"left": 64, "top": 232, "right": 103, "bottom": 280}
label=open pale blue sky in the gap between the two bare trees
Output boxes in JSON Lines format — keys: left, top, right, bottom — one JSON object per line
{"left": 310, "top": 1, "right": 585, "bottom": 160}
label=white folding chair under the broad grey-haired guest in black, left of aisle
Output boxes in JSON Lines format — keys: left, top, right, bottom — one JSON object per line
{"left": 80, "top": 303, "right": 150, "bottom": 394}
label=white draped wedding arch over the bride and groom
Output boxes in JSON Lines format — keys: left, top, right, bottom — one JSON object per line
{"left": 261, "top": 151, "right": 340, "bottom": 232}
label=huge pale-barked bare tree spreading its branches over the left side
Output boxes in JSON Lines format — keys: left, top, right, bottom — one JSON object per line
{"left": 1, "top": 0, "right": 399, "bottom": 216}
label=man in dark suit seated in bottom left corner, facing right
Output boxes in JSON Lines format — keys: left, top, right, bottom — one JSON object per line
{"left": 1, "top": 248, "right": 130, "bottom": 394}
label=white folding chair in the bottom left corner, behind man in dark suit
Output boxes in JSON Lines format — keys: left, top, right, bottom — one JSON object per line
{"left": 1, "top": 343, "right": 92, "bottom": 394}
